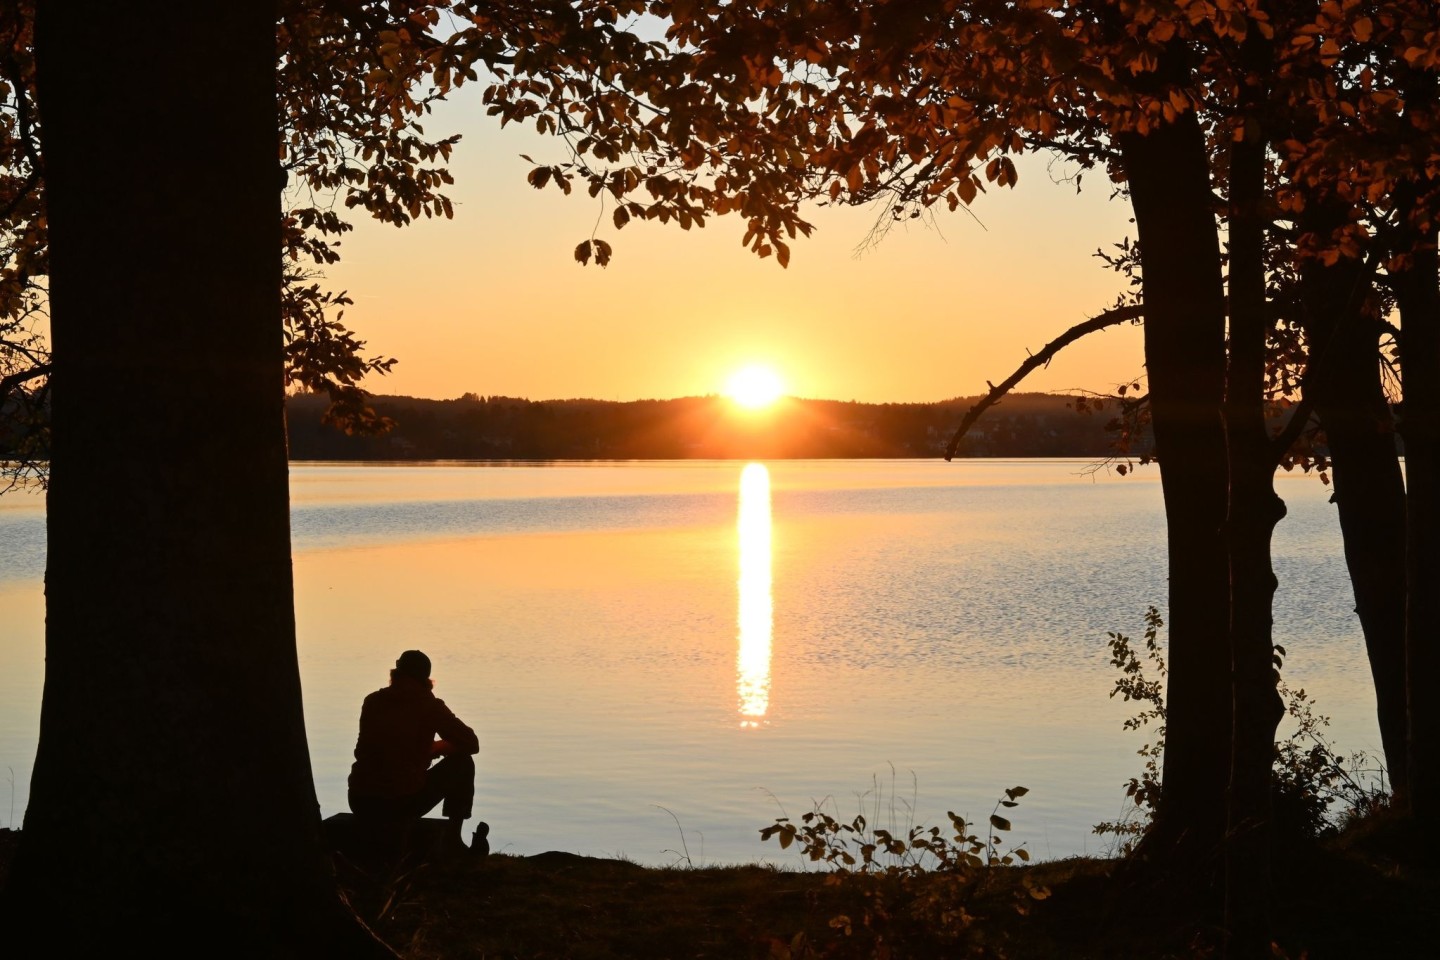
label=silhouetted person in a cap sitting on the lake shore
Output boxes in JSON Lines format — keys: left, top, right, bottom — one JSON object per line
{"left": 350, "top": 651, "right": 480, "bottom": 849}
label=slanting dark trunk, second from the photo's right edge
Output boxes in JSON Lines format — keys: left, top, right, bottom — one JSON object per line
{"left": 1300, "top": 211, "right": 1410, "bottom": 796}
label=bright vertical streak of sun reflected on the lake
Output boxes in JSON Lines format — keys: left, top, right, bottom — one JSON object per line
{"left": 736, "top": 463, "right": 773, "bottom": 727}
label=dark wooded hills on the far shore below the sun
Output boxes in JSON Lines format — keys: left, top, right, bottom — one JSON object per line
{"left": 287, "top": 393, "right": 1149, "bottom": 461}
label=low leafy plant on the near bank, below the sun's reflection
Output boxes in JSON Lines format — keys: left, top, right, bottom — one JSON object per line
{"left": 760, "top": 787, "right": 1050, "bottom": 960}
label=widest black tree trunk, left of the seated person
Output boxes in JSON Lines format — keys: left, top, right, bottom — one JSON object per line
{"left": 4, "top": 1, "right": 379, "bottom": 956}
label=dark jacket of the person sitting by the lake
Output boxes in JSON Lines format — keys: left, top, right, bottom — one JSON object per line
{"left": 350, "top": 676, "right": 480, "bottom": 797}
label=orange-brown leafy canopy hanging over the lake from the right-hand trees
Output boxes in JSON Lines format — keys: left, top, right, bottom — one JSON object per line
{"left": 484, "top": 0, "right": 1440, "bottom": 341}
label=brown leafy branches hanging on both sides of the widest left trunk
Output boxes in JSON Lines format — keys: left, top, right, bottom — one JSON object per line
{"left": 0, "top": 0, "right": 659, "bottom": 463}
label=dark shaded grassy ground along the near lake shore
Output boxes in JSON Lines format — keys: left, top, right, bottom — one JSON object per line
{"left": 0, "top": 830, "right": 1440, "bottom": 960}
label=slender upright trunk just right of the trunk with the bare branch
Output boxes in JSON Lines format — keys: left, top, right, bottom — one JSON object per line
{"left": 1225, "top": 107, "right": 1284, "bottom": 957}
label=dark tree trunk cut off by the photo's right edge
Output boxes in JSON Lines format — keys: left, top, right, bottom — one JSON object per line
{"left": 1395, "top": 230, "right": 1440, "bottom": 845}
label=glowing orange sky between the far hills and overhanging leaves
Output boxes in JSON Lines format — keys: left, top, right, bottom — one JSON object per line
{"left": 328, "top": 88, "right": 1142, "bottom": 403}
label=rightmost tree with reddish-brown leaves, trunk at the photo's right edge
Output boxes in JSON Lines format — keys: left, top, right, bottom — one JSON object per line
{"left": 1283, "top": 0, "right": 1440, "bottom": 841}
